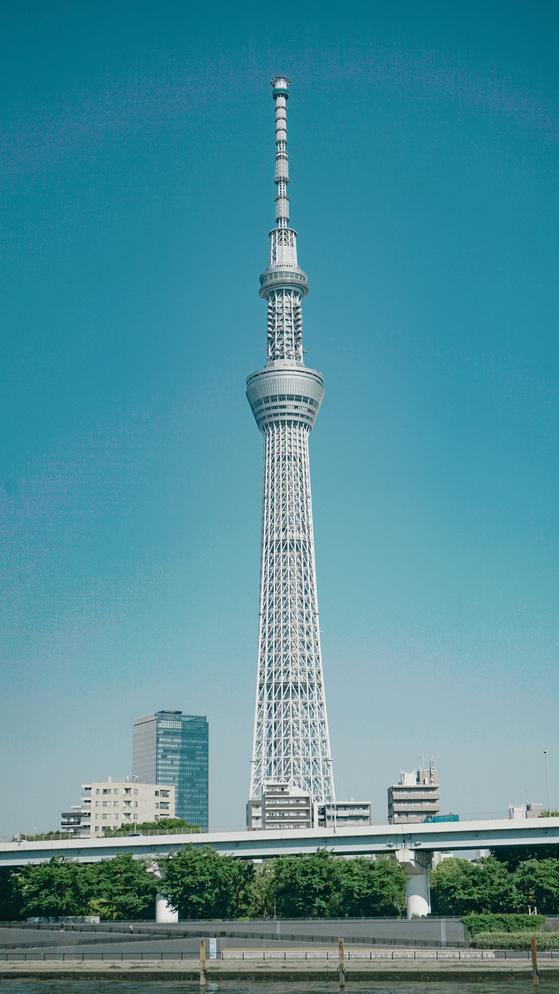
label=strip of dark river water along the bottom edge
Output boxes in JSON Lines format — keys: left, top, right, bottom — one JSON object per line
{"left": 0, "top": 977, "right": 548, "bottom": 994}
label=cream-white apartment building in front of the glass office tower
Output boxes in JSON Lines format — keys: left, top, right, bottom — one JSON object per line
{"left": 80, "top": 777, "right": 175, "bottom": 838}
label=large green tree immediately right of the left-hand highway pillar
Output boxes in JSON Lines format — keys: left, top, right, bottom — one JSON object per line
{"left": 159, "top": 845, "right": 254, "bottom": 918}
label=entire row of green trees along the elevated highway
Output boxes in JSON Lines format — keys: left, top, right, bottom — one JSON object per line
{"left": 0, "top": 846, "right": 559, "bottom": 920}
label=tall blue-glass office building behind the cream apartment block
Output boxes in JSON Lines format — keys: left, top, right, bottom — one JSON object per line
{"left": 132, "top": 711, "right": 209, "bottom": 832}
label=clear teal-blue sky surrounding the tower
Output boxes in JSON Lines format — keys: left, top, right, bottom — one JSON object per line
{"left": 0, "top": 0, "right": 559, "bottom": 836}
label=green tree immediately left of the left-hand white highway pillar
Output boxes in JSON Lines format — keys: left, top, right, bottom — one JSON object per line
{"left": 88, "top": 854, "right": 158, "bottom": 921}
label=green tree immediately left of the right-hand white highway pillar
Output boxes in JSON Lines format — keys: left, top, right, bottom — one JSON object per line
{"left": 340, "top": 857, "right": 406, "bottom": 918}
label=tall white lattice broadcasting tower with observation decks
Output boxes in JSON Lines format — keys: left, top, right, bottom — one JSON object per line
{"left": 247, "top": 76, "right": 335, "bottom": 803}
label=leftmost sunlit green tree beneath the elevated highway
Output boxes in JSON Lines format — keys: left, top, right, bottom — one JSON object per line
{"left": 12, "top": 857, "right": 91, "bottom": 918}
